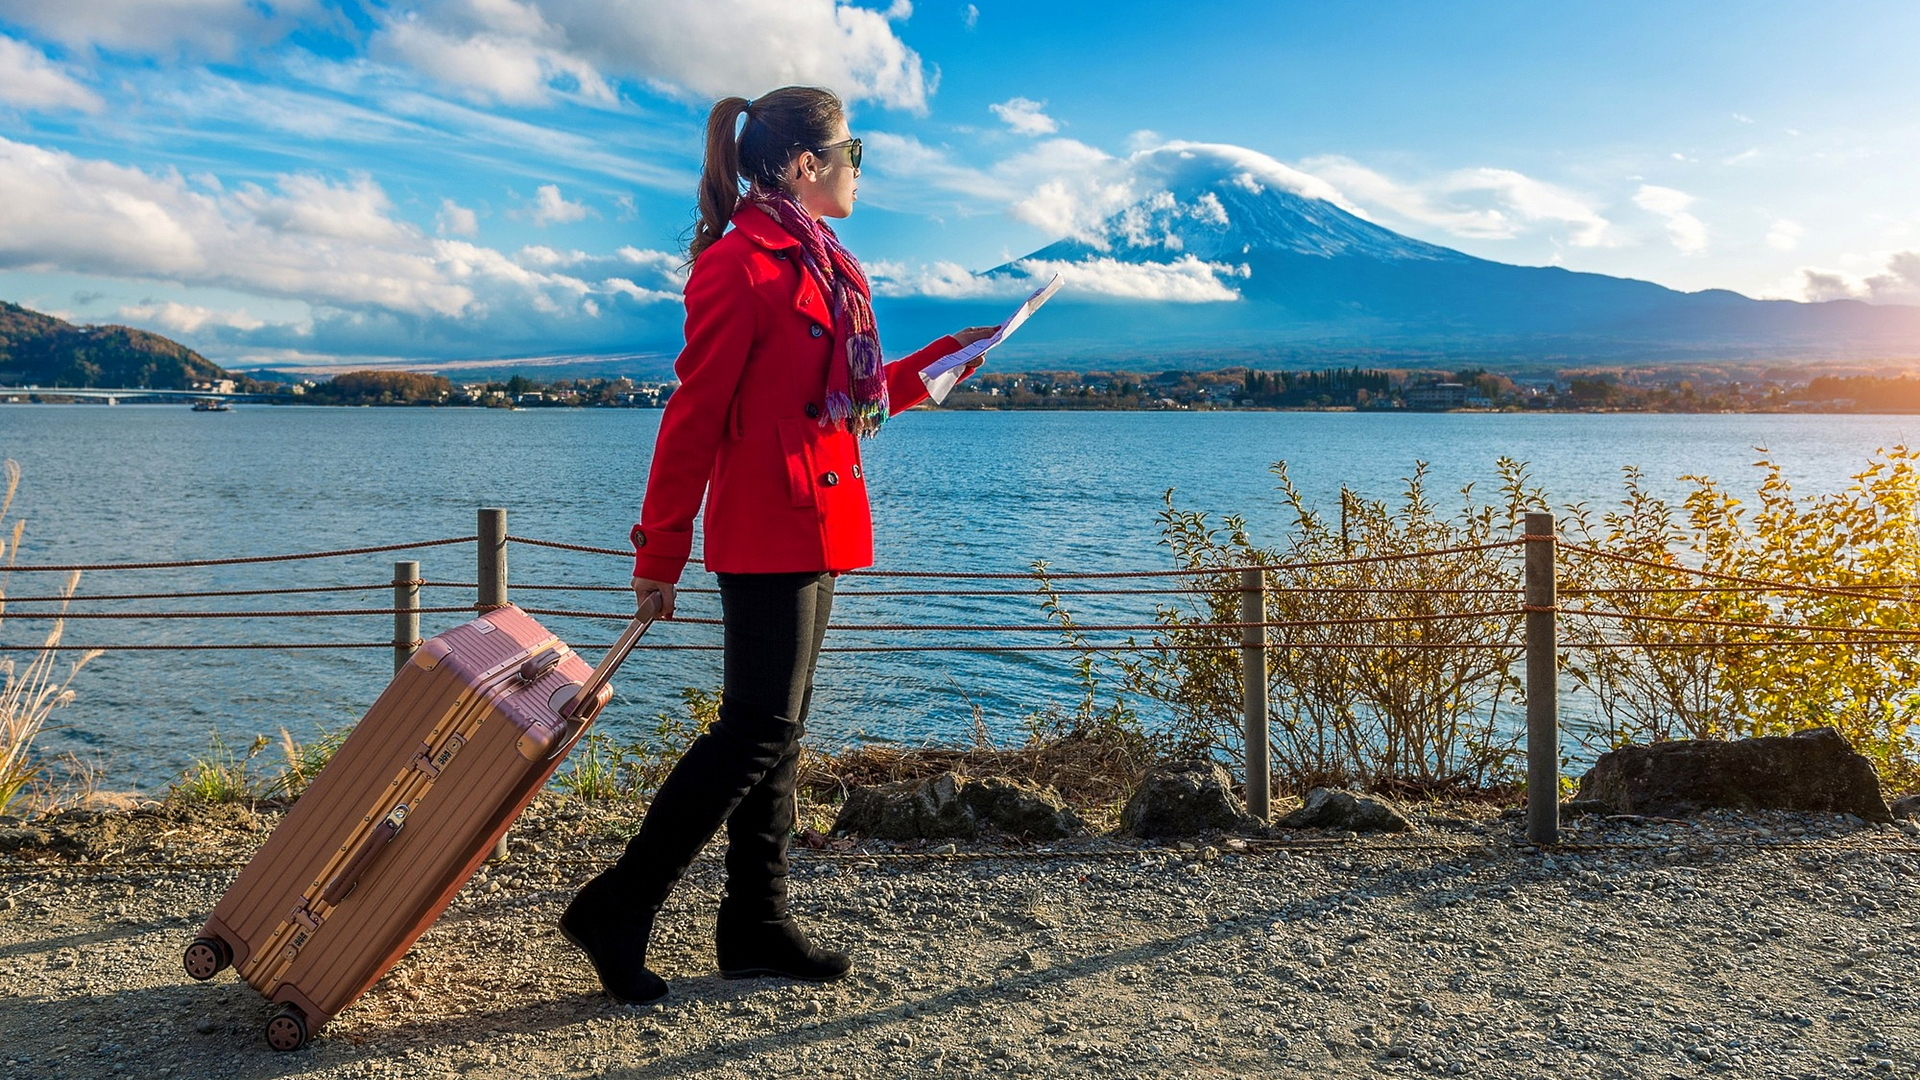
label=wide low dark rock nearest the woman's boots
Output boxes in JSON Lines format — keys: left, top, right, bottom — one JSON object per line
{"left": 833, "top": 773, "right": 1087, "bottom": 840}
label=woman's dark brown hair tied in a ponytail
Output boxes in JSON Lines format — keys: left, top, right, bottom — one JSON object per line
{"left": 687, "top": 86, "right": 845, "bottom": 263}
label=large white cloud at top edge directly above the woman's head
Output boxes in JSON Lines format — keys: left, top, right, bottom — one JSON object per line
{"left": 368, "top": 0, "right": 935, "bottom": 113}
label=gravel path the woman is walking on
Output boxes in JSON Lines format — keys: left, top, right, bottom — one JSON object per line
{"left": 0, "top": 803, "right": 1920, "bottom": 1080}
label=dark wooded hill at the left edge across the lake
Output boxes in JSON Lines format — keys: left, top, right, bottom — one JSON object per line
{"left": 0, "top": 300, "right": 248, "bottom": 390}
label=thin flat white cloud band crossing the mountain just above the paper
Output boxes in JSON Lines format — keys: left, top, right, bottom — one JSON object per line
{"left": 868, "top": 256, "right": 1250, "bottom": 304}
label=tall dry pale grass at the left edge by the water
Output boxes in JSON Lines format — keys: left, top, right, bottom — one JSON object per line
{"left": 0, "top": 459, "right": 100, "bottom": 813}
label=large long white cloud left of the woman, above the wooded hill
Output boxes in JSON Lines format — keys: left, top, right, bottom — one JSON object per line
{"left": 0, "top": 138, "right": 672, "bottom": 327}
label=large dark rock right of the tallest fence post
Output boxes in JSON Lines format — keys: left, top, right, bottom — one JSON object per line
{"left": 1578, "top": 728, "right": 1893, "bottom": 821}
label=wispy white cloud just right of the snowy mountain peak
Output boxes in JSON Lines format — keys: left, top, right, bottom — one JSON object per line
{"left": 1300, "top": 156, "right": 1620, "bottom": 248}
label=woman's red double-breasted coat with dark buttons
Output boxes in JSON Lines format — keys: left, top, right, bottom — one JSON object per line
{"left": 632, "top": 206, "right": 960, "bottom": 582}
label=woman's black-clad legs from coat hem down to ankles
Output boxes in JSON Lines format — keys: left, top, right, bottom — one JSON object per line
{"left": 609, "top": 573, "right": 833, "bottom": 919}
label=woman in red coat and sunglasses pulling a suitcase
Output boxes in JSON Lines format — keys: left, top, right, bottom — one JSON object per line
{"left": 561, "top": 86, "right": 993, "bottom": 1003}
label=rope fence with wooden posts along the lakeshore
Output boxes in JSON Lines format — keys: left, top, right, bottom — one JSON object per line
{"left": 11, "top": 507, "right": 1920, "bottom": 844}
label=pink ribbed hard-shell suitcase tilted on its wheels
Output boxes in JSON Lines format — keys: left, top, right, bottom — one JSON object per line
{"left": 184, "top": 598, "right": 659, "bottom": 1049}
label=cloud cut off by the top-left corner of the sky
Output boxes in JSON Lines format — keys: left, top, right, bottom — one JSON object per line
{"left": 0, "top": 0, "right": 324, "bottom": 58}
